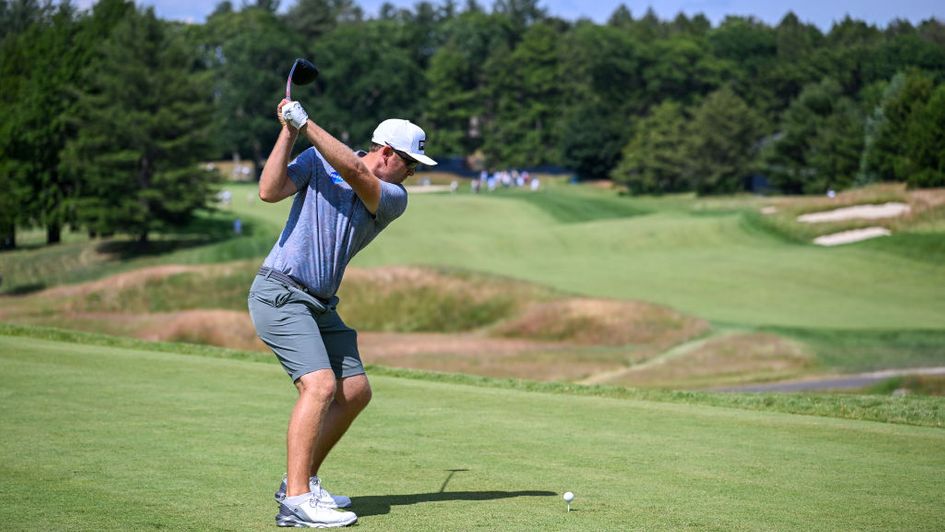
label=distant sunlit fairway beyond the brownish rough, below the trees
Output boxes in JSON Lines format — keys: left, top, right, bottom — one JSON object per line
{"left": 227, "top": 187, "right": 945, "bottom": 329}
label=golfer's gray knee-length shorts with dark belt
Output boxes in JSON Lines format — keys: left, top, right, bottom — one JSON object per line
{"left": 249, "top": 275, "right": 364, "bottom": 382}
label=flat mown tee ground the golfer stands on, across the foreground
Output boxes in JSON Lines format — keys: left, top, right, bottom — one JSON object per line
{"left": 0, "top": 336, "right": 945, "bottom": 530}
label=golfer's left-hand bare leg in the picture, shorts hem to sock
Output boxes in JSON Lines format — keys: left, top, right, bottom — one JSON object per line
{"left": 286, "top": 369, "right": 336, "bottom": 497}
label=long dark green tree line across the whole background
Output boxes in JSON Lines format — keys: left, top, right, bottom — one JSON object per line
{"left": 0, "top": 0, "right": 945, "bottom": 247}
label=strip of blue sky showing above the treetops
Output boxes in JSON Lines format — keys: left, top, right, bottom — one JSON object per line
{"left": 94, "top": 0, "right": 945, "bottom": 30}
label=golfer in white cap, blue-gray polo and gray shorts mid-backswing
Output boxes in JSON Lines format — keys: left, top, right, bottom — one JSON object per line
{"left": 248, "top": 100, "right": 436, "bottom": 528}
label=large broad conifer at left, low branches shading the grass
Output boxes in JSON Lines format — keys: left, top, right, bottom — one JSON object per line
{"left": 66, "top": 3, "right": 213, "bottom": 241}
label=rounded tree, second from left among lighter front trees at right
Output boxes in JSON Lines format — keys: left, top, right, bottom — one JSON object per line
{"left": 685, "top": 87, "right": 763, "bottom": 194}
